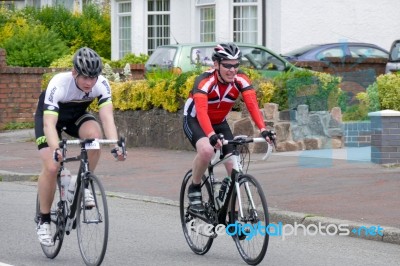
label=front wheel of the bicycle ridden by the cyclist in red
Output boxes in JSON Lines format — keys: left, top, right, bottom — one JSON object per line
{"left": 230, "top": 174, "right": 269, "bottom": 265}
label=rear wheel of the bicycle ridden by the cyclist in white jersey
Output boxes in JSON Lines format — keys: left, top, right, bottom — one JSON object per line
{"left": 34, "top": 186, "right": 65, "bottom": 259}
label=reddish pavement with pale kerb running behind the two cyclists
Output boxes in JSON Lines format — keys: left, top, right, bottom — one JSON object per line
{"left": 0, "top": 129, "right": 400, "bottom": 245}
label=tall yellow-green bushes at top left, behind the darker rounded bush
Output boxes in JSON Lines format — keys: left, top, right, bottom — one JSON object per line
{"left": 0, "top": 4, "right": 111, "bottom": 62}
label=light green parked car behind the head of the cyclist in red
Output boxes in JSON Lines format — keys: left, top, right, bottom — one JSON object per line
{"left": 145, "top": 43, "right": 295, "bottom": 77}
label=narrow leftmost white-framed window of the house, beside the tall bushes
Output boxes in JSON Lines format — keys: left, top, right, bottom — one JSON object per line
{"left": 118, "top": 2, "right": 132, "bottom": 58}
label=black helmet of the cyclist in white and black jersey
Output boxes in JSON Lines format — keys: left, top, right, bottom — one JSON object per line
{"left": 73, "top": 47, "right": 103, "bottom": 77}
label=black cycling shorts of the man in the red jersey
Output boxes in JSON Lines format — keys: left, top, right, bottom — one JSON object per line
{"left": 183, "top": 115, "right": 233, "bottom": 154}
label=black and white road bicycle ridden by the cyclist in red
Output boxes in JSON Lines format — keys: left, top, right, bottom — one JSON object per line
{"left": 179, "top": 132, "right": 275, "bottom": 265}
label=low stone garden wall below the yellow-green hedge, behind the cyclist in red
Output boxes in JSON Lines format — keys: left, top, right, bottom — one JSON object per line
{"left": 115, "top": 104, "right": 343, "bottom": 153}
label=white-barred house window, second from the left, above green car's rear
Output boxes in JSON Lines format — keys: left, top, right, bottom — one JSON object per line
{"left": 147, "top": 0, "right": 171, "bottom": 55}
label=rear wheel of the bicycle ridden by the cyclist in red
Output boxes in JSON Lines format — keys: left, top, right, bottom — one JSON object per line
{"left": 179, "top": 170, "right": 214, "bottom": 255}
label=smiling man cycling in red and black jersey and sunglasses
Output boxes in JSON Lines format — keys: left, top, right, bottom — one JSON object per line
{"left": 183, "top": 43, "right": 270, "bottom": 212}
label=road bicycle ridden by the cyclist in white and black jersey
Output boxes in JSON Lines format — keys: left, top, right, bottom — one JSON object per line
{"left": 34, "top": 137, "right": 126, "bottom": 265}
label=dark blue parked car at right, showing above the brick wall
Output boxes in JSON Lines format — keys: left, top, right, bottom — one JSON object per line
{"left": 282, "top": 42, "right": 389, "bottom": 62}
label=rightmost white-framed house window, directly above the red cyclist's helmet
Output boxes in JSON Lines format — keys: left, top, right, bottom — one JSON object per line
{"left": 233, "top": 0, "right": 258, "bottom": 43}
